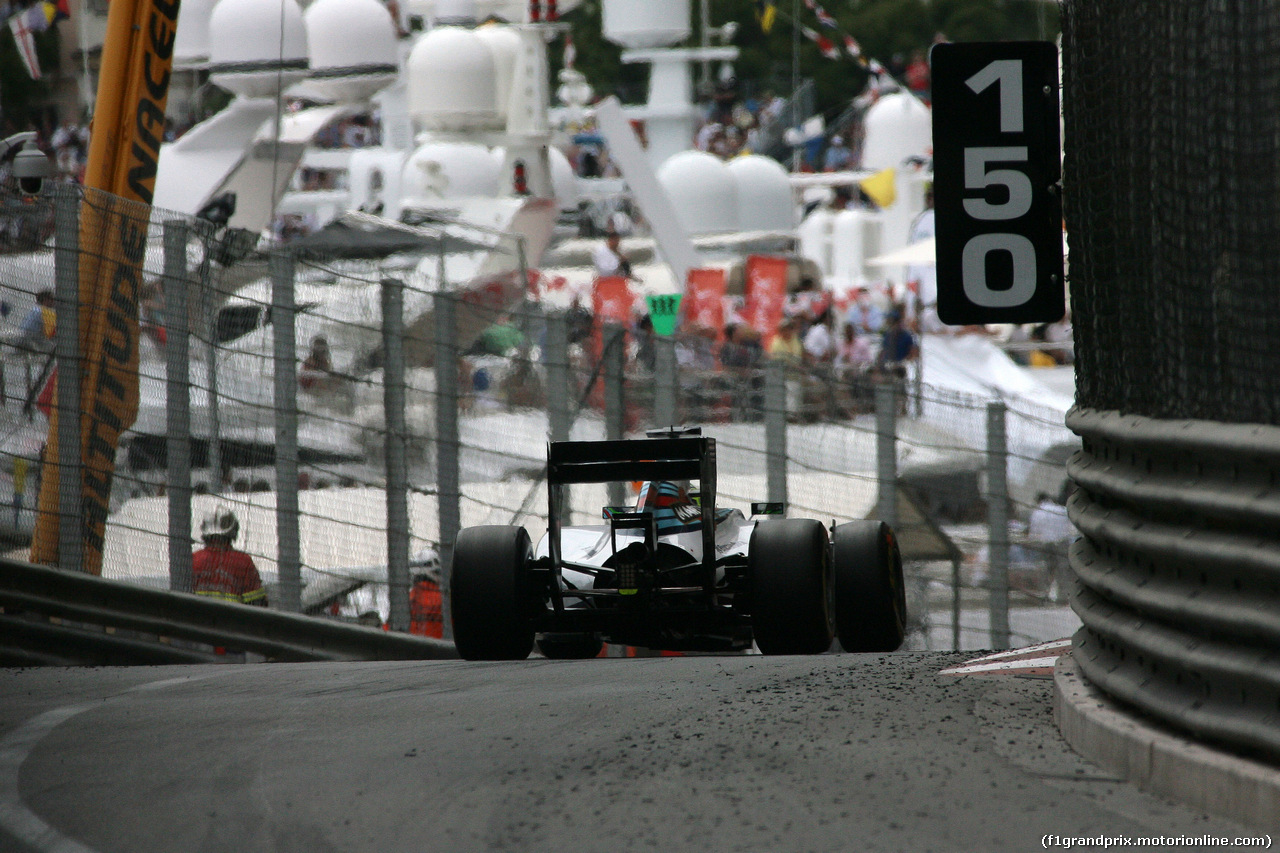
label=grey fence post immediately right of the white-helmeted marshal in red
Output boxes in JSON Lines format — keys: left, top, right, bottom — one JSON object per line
{"left": 270, "top": 251, "right": 302, "bottom": 613}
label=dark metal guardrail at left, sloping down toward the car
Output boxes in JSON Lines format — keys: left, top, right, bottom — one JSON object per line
{"left": 0, "top": 558, "right": 457, "bottom": 665}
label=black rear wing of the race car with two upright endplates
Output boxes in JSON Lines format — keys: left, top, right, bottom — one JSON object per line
{"left": 547, "top": 435, "right": 716, "bottom": 584}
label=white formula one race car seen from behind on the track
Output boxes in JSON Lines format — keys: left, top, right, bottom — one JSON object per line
{"left": 452, "top": 429, "right": 906, "bottom": 661}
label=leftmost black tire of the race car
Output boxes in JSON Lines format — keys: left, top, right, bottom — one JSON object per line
{"left": 449, "top": 525, "right": 535, "bottom": 661}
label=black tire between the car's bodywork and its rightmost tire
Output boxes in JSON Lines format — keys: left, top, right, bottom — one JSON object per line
{"left": 746, "top": 519, "right": 835, "bottom": 654}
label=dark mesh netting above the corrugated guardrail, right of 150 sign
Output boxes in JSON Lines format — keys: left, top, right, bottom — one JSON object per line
{"left": 1062, "top": 0, "right": 1280, "bottom": 424}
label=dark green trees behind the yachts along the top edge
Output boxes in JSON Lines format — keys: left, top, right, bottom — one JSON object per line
{"left": 552, "top": 0, "right": 1060, "bottom": 124}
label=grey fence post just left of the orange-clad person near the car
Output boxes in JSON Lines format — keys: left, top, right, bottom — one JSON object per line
{"left": 383, "top": 278, "right": 410, "bottom": 631}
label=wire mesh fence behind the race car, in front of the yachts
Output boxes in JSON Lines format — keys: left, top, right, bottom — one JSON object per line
{"left": 0, "top": 183, "right": 1075, "bottom": 648}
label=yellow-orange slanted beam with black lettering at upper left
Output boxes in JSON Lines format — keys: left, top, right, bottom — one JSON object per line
{"left": 31, "top": 0, "right": 178, "bottom": 575}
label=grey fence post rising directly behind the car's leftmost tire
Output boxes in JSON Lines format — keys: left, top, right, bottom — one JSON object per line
{"left": 435, "top": 292, "right": 462, "bottom": 639}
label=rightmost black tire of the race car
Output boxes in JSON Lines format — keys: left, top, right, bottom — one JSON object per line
{"left": 832, "top": 521, "right": 906, "bottom": 652}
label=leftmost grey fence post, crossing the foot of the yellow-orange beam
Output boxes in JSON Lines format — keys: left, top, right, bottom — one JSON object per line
{"left": 54, "top": 186, "right": 84, "bottom": 571}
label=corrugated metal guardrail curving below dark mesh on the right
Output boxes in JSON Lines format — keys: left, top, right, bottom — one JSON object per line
{"left": 1066, "top": 409, "right": 1280, "bottom": 757}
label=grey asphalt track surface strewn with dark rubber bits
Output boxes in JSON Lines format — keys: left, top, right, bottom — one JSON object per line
{"left": 0, "top": 652, "right": 1245, "bottom": 853}
